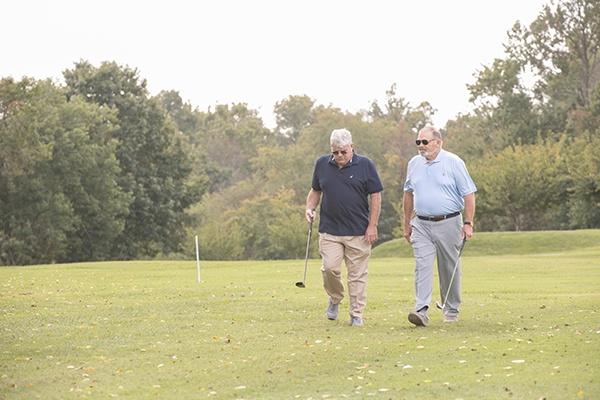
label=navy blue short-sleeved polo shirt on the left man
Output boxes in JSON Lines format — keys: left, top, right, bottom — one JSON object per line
{"left": 312, "top": 154, "right": 383, "bottom": 236}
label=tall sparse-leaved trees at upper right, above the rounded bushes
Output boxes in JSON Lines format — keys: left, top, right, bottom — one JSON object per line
{"left": 451, "top": 0, "right": 600, "bottom": 154}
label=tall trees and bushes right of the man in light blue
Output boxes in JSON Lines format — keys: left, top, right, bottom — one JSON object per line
{"left": 446, "top": 0, "right": 600, "bottom": 234}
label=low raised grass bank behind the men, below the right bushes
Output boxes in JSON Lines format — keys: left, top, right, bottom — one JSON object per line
{"left": 373, "top": 229, "right": 600, "bottom": 257}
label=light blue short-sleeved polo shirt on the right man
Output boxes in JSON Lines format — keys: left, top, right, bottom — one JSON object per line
{"left": 404, "top": 149, "right": 477, "bottom": 216}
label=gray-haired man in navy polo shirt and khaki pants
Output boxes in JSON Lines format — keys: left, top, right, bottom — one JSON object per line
{"left": 305, "top": 129, "right": 383, "bottom": 326}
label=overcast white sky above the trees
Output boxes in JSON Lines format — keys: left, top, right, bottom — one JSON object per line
{"left": 0, "top": 0, "right": 548, "bottom": 127}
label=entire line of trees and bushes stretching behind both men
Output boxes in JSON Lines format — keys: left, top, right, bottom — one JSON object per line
{"left": 0, "top": 0, "right": 600, "bottom": 265}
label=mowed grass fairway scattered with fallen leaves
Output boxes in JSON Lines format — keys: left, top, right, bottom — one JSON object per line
{"left": 0, "top": 231, "right": 600, "bottom": 399}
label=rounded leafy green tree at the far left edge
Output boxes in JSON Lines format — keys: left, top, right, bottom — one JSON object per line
{"left": 0, "top": 79, "right": 130, "bottom": 264}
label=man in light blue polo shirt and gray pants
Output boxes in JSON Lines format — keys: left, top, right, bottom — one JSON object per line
{"left": 403, "top": 126, "right": 477, "bottom": 326}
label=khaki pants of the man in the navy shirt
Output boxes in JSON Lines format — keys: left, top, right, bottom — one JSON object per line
{"left": 319, "top": 233, "right": 371, "bottom": 317}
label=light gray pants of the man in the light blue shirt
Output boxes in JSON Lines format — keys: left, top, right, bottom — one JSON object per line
{"left": 410, "top": 216, "right": 462, "bottom": 314}
